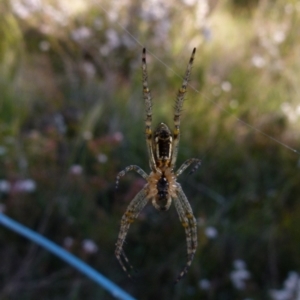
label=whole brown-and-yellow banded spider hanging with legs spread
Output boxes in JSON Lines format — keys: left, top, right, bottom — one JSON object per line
{"left": 115, "top": 48, "right": 201, "bottom": 283}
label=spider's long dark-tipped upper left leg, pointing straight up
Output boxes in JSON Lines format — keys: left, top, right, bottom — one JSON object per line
{"left": 142, "top": 48, "right": 156, "bottom": 171}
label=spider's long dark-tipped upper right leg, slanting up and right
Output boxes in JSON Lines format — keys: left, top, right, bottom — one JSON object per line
{"left": 171, "top": 48, "right": 196, "bottom": 168}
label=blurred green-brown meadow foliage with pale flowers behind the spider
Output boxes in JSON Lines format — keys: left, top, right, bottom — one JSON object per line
{"left": 0, "top": 0, "right": 300, "bottom": 300}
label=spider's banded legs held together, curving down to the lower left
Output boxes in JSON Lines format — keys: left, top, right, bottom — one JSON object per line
{"left": 115, "top": 186, "right": 148, "bottom": 278}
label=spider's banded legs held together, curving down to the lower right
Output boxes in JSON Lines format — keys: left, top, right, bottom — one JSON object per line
{"left": 174, "top": 183, "right": 198, "bottom": 283}
